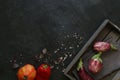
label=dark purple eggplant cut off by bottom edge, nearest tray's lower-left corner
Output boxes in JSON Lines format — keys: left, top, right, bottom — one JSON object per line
{"left": 77, "top": 59, "right": 94, "bottom": 80}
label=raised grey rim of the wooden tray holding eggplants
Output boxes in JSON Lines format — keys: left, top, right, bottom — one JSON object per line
{"left": 64, "top": 19, "right": 120, "bottom": 80}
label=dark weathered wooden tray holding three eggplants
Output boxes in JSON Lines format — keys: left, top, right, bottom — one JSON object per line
{"left": 64, "top": 19, "right": 120, "bottom": 80}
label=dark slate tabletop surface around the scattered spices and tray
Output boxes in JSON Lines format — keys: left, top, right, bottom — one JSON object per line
{"left": 0, "top": 0, "right": 120, "bottom": 80}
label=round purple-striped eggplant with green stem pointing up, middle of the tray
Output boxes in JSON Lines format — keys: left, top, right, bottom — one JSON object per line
{"left": 88, "top": 52, "right": 103, "bottom": 74}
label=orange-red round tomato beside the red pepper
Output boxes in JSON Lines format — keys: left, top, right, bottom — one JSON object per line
{"left": 17, "top": 64, "right": 36, "bottom": 80}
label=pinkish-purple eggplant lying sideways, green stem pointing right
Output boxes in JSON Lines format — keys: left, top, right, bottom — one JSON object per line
{"left": 93, "top": 42, "right": 117, "bottom": 52}
